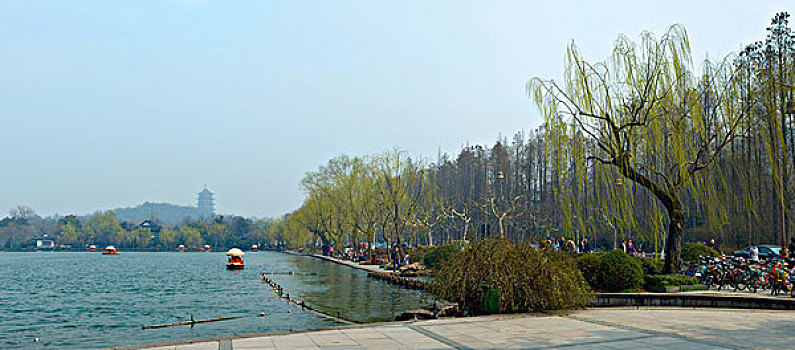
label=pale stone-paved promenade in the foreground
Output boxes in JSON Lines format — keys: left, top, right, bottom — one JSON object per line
{"left": 132, "top": 308, "right": 795, "bottom": 350}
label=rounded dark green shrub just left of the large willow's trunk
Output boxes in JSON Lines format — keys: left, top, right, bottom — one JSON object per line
{"left": 598, "top": 249, "right": 643, "bottom": 292}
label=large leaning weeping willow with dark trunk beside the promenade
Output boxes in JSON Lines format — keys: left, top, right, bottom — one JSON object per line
{"left": 528, "top": 25, "right": 747, "bottom": 273}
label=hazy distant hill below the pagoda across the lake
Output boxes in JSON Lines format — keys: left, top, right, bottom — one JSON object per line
{"left": 113, "top": 202, "right": 213, "bottom": 225}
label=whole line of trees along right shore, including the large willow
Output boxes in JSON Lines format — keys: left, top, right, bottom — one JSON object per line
{"left": 274, "top": 13, "right": 795, "bottom": 271}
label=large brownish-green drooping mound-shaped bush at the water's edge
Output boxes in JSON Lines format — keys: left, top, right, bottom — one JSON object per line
{"left": 432, "top": 239, "right": 592, "bottom": 313}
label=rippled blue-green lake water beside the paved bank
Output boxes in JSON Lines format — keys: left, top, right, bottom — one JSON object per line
{"left": 0, "top": 252, "right": 433, "bottom": 349}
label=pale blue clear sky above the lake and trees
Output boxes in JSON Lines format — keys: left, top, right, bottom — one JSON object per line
{"left": 0, "top": 0, "right": 795, "bottom": 217}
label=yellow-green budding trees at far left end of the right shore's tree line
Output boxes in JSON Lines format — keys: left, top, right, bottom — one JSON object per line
{"left": 271, "top": 151, "right": 438, "bottom": 253}
